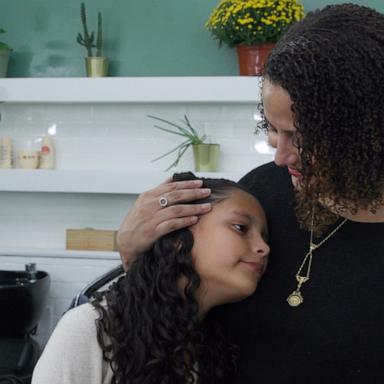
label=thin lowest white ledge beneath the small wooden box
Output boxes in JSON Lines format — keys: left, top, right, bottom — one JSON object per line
{"left": 0, "top": 247, "right": 120, "bottom": 260}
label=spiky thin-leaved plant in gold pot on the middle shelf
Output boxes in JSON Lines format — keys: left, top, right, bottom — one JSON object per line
{"left": 148, "top": 115, "right": 220, "bottom": 172}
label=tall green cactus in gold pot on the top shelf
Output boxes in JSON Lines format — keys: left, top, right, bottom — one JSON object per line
{"left": 77, "top": 3, "right": 108, "bottom": 77}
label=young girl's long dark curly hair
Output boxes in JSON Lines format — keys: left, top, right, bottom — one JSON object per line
{"left": 89, "top": 173, "right": 252, "bottom": 384}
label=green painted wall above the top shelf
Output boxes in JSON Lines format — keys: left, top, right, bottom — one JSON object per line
{"left": 0, "top": 0, "right": 384, "bottom": 77}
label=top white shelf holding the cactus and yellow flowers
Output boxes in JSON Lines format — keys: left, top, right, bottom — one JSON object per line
{"left": 0, "top": 76, "right": 261, "bottom": 103}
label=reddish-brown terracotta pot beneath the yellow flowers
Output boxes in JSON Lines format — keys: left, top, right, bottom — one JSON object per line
{"left": 236, "top": 43, "right": 276, "bottom": 76}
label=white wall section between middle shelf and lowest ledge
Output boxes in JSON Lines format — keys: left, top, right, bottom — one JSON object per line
{"left": 0, "top": 192, "right": 136, "bottom": 250}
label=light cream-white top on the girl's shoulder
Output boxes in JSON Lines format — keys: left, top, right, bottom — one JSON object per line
{"left": 32, "top": 303, "right": 113, "bottom": 384}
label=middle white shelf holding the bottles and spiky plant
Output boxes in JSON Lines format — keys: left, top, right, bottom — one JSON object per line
{"left": 0, "top": 169, "right": 243, "bottom": 194}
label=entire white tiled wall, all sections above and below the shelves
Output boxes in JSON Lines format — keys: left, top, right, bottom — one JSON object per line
{"left": 0, "top": 103, "right": 272, "bottom": 344}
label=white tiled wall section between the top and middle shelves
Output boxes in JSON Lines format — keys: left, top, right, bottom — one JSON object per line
{"left": 0, "top": 103, "right": 271, "bottom": 172}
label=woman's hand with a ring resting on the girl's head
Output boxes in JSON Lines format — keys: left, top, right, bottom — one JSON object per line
{"left": 117, "top": 178, "right": 211, "bottom": 269}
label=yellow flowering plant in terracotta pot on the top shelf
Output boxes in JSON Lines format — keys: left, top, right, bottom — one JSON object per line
{"left": 205, "top": 0, "right": 304, "bottom": 76}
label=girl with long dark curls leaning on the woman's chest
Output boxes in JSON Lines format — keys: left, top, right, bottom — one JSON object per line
{"left": 32, "top": 173, "right": 269, "bottom": 384}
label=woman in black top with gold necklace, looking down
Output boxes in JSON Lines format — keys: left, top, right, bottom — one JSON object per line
{"left": 119, "top": 4, "right": 384, "bottom": 384}
